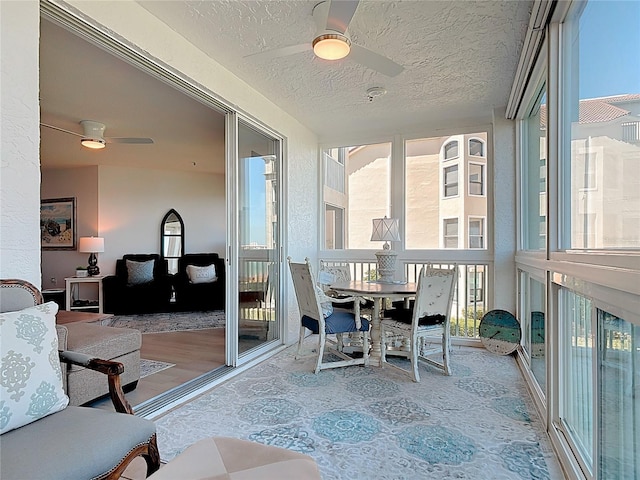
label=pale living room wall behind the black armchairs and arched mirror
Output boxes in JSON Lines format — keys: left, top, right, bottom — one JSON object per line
{"left": 98, "top": 166, "right": 227, "bottom": 275}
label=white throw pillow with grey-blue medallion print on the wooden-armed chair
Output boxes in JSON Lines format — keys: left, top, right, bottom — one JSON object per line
{"left": 0, "top": 302, "right": 69, "bottom": 434}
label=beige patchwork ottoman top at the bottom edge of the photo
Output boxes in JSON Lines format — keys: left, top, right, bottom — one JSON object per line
{"left": 149, "top": 437, "right": 320, "bottom": 480}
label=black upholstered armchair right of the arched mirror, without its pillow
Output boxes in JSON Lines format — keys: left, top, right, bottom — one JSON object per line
{"left": 174, "top": 253, "right": 225, "bottom": 311}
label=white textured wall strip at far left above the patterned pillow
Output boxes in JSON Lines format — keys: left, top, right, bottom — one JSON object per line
{"left": 0, "top": 1, "right": 40, "bottom": 287}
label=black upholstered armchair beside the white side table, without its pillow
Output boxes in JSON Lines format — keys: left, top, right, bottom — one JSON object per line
{"left": 102, "top": 253, "right": 171, "bottom": 315}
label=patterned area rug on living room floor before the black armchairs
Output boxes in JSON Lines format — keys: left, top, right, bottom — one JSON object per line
{"left": 101, "top": 310, "right": 225, "bottom": 333}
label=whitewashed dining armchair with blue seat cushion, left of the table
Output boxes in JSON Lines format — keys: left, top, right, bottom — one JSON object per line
{"left": 288, "top": 257, "right": 369, "bottom": 373}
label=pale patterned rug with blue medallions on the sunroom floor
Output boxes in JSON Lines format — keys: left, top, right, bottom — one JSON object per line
{"left": 156, "top": 342, "right": 563, "bottom": 480}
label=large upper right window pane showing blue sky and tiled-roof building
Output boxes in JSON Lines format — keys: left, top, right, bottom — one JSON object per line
{"left": 560, "top": 1, "right": 640, "bottom": 250}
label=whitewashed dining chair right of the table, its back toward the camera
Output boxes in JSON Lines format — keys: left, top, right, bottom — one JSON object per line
{"left": 380, "top": 265, "right": 458, "bottom": 382}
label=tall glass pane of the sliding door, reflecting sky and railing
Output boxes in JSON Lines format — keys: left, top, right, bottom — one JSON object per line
{"left": 234, "top": 120, "right": 281, "bottom": 357}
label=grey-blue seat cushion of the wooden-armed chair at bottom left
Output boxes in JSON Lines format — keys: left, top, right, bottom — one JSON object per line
{"left": 0, "top": 407, "right": 156, "bottom": 480}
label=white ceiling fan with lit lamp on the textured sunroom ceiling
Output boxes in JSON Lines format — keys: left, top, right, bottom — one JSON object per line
{"left": 245, "top": 0, "right": 404, "bottom": 77}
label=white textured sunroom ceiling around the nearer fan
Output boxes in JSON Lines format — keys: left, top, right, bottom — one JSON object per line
{"left": 138, "top": 0, "right": 532, "bottom": 139}
